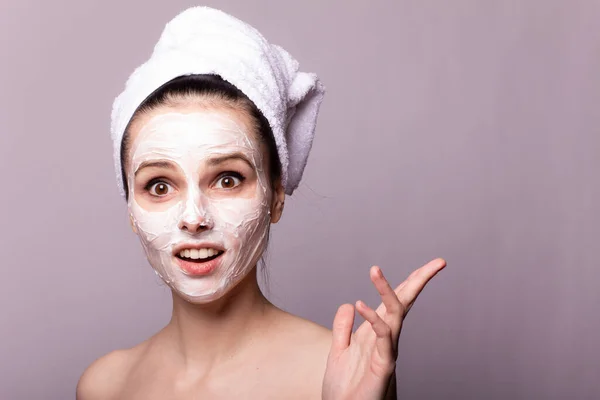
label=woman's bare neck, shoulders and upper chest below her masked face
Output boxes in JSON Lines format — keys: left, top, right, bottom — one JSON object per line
{"left": 77, "top": 271, "right": 331, "bottom": 400}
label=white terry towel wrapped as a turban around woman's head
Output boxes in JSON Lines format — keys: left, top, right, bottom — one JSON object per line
{"left": 111, "top": 7, "right": 325, "bottom": 196}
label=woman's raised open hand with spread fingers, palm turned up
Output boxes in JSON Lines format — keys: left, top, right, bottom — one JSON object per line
{"left": 322, "top": 258, "right": 446, "bottom": 400}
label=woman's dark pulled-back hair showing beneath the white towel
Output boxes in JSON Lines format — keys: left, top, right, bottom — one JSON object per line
{"left": 120, "top": 74, "right": 281, "bottom": 200}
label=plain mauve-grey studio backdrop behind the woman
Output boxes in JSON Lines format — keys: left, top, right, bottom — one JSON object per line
{"left": 0, "top": 0, "right": 600, "bottom": 400}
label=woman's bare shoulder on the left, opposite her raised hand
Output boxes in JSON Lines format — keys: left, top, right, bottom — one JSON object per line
{"left": 76, "top": 342, "right": 147, "bottom": 400}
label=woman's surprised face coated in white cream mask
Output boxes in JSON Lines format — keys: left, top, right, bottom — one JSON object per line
{"left": 127, "top": 110, "right": 271, "bottom": 303}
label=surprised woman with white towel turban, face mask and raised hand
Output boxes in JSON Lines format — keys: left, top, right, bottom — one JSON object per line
{"left": 77, "top": 7, "right": 445, "bottom": 400}
